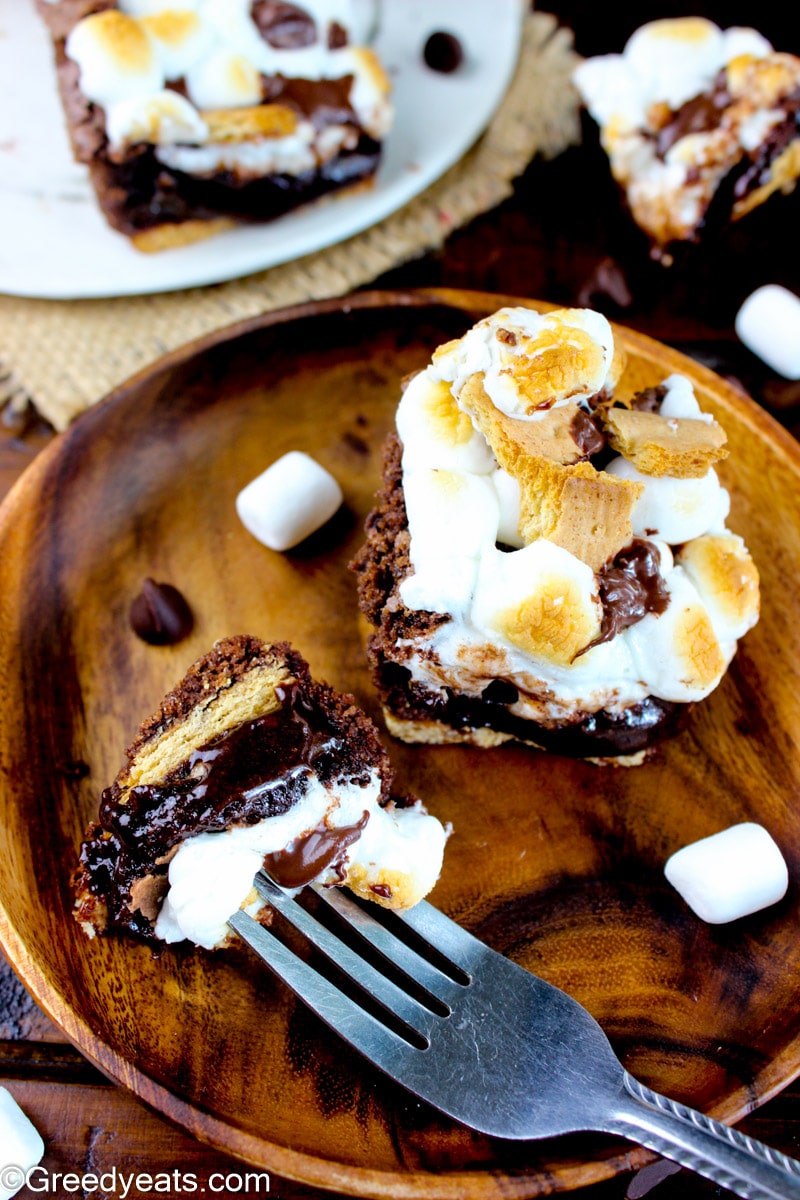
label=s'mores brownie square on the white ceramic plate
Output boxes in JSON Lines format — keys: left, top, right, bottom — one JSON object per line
{"left": 36, "top": 0, "right": 392, "bottom": 251}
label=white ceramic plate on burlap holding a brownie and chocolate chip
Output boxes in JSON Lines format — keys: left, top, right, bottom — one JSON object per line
{"left": 0, "top": 0, "right": 522, "bottom": 299}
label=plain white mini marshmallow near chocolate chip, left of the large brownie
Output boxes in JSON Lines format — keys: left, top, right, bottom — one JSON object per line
{"left": 236, "top": 450, "right": 343, "bottom": 550}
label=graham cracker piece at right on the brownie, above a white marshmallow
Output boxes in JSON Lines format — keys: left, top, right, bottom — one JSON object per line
{"left": 602, "top": 408, "right": 728, "bottom": 479}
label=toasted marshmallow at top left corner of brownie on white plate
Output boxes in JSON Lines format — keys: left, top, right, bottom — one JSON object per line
{"left": 66, "top": 8, "right": 164, "bottom": 107}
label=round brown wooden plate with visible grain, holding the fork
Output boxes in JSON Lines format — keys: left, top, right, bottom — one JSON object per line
{"left": 0, "top": 292, "right": 800, "bottom": 1200}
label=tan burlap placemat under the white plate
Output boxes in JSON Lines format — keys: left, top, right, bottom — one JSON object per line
{"left": 0, "top": 12, "right": 579, "bottom": 430}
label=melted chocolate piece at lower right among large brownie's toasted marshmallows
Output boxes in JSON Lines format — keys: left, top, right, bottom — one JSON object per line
{"left": 581, "top": 541, "right": 669, "bottom": 654}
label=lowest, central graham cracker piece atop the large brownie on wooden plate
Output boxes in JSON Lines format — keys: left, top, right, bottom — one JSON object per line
{"left": 517, "top": 457, "right": 644, "bottom": 571}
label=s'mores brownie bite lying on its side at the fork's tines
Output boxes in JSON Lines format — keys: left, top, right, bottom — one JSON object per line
{"left": 73, "top": 635, "right": 446, "bottom": 949}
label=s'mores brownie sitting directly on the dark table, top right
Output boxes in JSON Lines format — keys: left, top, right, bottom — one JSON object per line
{"left": 573, "top": 17, "right": 800, "bottom": 264}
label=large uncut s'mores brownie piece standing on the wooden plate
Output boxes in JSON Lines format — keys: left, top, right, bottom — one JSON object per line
{"left": 353, "top": 307, "right": 759, "bottom": 764}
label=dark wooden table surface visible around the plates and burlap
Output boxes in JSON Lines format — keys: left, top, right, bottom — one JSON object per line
{"left": 0, "top": 0, "right": 800, "bottom": 1200}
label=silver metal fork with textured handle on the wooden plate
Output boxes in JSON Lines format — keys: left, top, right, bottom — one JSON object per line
{"left": 229, "top": 872, "right": 800, "bottom": 1200}
